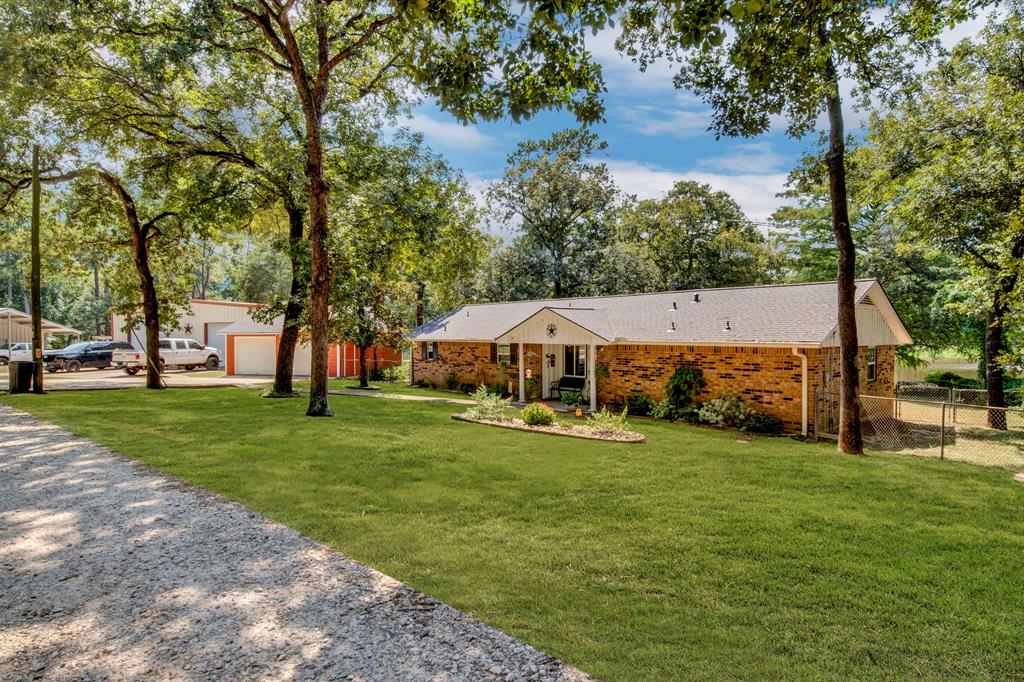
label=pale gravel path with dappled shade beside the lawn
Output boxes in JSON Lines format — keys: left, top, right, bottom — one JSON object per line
{"left": 0, "top": 406, "right": 588, "bottom": 680}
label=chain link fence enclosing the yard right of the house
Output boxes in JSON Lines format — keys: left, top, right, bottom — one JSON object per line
{"left": 860, "top": 386, "right": 1024, "bottom": 470}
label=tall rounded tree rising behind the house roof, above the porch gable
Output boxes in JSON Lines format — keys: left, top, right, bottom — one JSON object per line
{"left": 487, "top": 129, "right": 618, "bottom": 298}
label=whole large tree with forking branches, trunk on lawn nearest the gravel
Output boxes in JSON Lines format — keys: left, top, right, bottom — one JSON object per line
{"left": 200, "top": 0, "right": 605, "bottom": 416}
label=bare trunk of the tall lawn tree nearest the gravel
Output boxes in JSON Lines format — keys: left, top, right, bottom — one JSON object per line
{"left": 305, "top": 111, "right": 334, "bottom": 417}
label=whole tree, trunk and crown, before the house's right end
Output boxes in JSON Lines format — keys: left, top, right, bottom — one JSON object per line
{"left": 618, "top": 0, "right": 965, "bottom": 454}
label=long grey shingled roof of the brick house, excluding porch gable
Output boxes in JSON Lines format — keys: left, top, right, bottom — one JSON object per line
{"left": 412, "top": 280, "right": 912, "bottom": 346}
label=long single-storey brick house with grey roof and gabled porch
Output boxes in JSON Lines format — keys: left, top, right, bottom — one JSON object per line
{"left": 412, "top": 280, "right": 912, "bottom": 434}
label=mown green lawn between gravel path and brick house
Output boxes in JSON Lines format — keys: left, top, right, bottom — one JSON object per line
{"left": 2, "top": 388, "right": 1024, "bottom": 680}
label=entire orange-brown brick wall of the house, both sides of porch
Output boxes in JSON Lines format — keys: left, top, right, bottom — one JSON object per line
{"left": 413, "top": 342, "right": 895, "bottom": 431}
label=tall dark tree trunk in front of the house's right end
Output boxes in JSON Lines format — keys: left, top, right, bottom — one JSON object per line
{"left": 825, "top": 49, "right": 864, "bottom": 455}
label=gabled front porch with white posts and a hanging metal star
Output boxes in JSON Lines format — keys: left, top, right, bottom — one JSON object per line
{"left": 496, "top": 307, "right": 610, "bottom": 411}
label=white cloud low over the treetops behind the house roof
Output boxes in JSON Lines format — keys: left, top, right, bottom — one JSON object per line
{"left": 606, "top": 160, "right": 786, "bottom": 221}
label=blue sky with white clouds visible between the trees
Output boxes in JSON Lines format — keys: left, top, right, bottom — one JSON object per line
{"left": 407, "top": 20, "right": 982, "bottom": 220}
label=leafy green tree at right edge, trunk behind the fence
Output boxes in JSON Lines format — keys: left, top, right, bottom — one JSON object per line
{"left": 867, "top": 12, "right": 1024, "bottom": 419}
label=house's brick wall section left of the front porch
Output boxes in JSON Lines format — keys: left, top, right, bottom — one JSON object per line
{"left": 413, "top": 341, "right": 544, "bottom": 396}
